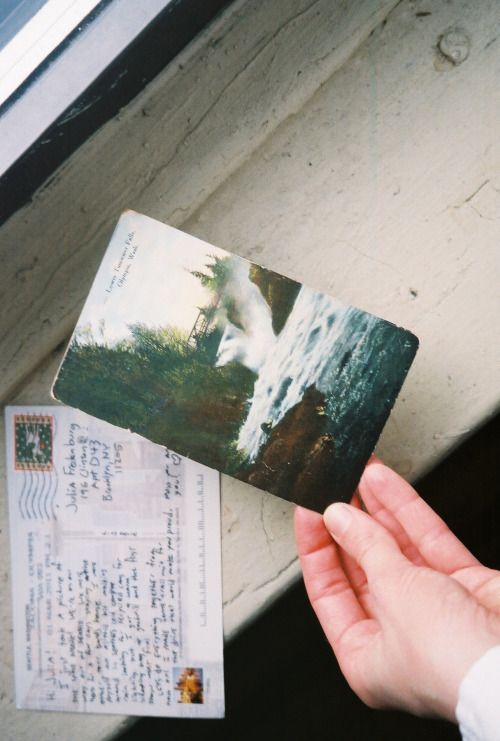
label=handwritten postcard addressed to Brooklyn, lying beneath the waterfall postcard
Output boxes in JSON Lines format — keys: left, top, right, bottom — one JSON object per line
{"left": 6, "top": 406, "right": 224, "bottom": 718}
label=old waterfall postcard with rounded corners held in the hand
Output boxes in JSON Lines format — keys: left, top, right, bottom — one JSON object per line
{"left": 53, "top": 211, "right": 418, "bottom": 511}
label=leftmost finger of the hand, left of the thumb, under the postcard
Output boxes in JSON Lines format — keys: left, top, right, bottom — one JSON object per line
{"left": 295, "top": 507, "right": 367, "bottom": 644}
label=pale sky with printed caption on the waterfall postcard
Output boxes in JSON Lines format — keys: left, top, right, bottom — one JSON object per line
{"left": 78, "top": 211, "right": 228, "bottom": 344}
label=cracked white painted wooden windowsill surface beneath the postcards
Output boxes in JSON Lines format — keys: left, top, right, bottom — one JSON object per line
{"left": 0, "top": 0, "right": 500, "bottom": 741}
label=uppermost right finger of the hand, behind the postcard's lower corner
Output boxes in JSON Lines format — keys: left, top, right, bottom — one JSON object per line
{"left": 359, "top": 459, "right": 479, "bottom": 574}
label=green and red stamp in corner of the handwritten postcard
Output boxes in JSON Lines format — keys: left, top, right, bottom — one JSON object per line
{"left": 14, "top": 414, "right": 54, "bottom": 471}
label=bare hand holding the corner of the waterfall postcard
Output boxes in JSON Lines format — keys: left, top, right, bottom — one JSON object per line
{"left": 295, "top": 458, "right": 500, "bottom": 720}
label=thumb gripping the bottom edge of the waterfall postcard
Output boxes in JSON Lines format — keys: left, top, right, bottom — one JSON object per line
{"left": 323, "top": 502, "right": 408, "bottom": 582}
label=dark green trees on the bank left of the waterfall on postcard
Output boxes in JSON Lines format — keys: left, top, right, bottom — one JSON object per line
{"left": 55, "top": 316, "right": 254, "bottom": 468}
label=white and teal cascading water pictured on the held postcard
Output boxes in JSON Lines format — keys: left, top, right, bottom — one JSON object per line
{"left": 217, "top": 268, "right": 416, "bottom": 492}
